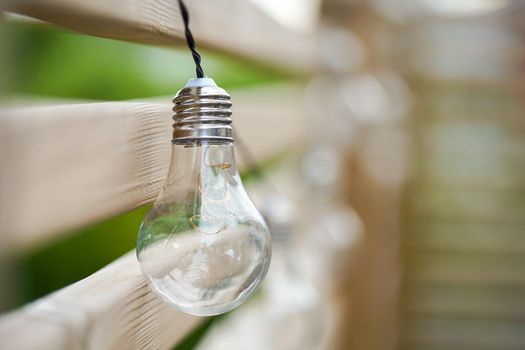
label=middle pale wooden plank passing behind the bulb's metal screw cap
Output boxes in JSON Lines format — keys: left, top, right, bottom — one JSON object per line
{"left": 0, "top": 86, "right": 304, "bottom": 256}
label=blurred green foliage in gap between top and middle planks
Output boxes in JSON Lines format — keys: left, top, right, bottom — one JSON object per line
{"left": 3, "top": 23, "right": 284, "bottom": 100}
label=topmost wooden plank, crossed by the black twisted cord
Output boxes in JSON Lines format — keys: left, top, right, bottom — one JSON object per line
{"left": 2, "top": 0, "right": 316, "bottom": 72}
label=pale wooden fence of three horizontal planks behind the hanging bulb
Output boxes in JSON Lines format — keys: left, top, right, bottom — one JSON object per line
{"left": 0, "top": 0, "right": 315, "bottom": 349}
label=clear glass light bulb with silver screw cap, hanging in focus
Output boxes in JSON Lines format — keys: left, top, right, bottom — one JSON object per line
{"left": 137, "top": 78, "right": 271, "bottom": 316}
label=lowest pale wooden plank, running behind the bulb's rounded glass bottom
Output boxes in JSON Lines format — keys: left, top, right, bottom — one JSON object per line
{"left": 0, "top": 252, "right": 203, "bottom": 350}
